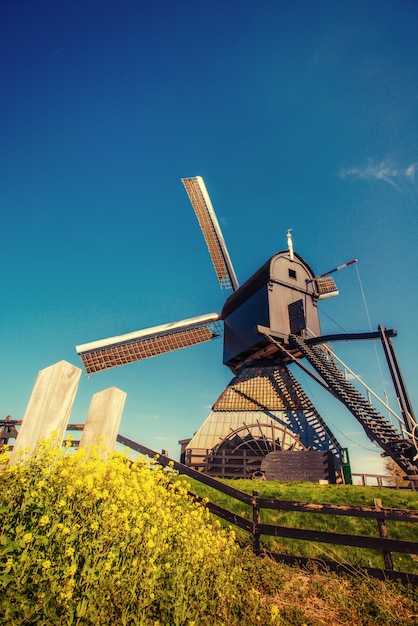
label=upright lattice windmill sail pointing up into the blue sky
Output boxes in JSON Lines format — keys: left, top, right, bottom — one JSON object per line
{"left": 181, "top": 176, "right": 239, "bottom": 291}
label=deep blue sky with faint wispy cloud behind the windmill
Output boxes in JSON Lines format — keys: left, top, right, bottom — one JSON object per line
{"left": 0, "top": 0, "right": 418, "bottom": 471}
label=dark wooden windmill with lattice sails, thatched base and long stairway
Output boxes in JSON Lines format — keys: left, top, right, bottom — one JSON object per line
{"left": 76, "top": 177, "right": 416, "bottom": 479}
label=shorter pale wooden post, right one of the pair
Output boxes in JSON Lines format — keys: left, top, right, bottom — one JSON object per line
{"left": 80, "top": 387, "right": 126, "bottom": 452}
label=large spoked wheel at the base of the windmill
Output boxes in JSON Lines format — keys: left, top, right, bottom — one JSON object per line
{"left": 207, "top": 422, "right": 307, "bottom": 478}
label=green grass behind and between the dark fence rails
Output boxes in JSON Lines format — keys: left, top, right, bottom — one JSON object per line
{"left": 181, "top": 479, "right": 418, "bottom": 574}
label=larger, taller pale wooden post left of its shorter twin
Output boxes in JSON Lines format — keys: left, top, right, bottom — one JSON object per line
{"left": 9, "top": 361, "right": 81, "bottom": 465}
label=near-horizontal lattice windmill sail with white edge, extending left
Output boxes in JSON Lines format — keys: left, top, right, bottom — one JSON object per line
{"left": 76, "top": 313, "right": 222, "bottom": 374}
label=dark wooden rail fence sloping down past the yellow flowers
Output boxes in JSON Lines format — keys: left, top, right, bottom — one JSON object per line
{"left": 117, "top": 435, "right": 418, "bottom": 585}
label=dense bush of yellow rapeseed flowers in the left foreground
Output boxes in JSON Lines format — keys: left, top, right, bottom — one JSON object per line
{"left": 0, "top": 440, "right": 264, "bottom": 626}
